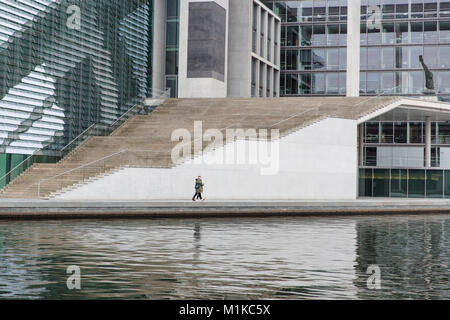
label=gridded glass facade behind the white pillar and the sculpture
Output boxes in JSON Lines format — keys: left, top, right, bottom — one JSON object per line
{"left": 263, "top": 0, "right": 450, "bottom": 99}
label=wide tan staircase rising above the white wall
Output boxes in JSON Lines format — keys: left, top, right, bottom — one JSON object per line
{"left": 0, "top": 97, "right": 397, "bottom": 199}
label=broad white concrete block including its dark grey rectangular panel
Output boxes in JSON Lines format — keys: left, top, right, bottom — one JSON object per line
{"left": 178, "top": 0, "right": 229, "bottom": 98}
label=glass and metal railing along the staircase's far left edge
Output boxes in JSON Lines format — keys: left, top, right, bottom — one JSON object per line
{"left": 0, "top": 89, "right": 170, "bottom": 189}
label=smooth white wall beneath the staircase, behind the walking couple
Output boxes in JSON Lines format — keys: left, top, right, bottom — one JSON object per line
{"left": 58, "top": 119, "right": 357, "bottom": 200}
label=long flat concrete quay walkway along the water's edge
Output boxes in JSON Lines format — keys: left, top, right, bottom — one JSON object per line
{"left": 0, "top": 199, "right": 450, "bottom": 219}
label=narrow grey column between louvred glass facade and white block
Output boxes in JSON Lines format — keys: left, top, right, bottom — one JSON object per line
{"left": 152, "top": 0, "right": 167, "bottom": 92}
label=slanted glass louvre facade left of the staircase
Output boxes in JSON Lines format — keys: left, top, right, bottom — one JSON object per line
{"left": 0, "top": 0, "right": 152, "bottom": 185}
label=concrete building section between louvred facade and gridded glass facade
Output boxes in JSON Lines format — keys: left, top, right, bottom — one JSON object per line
{"left": 153, "top": 0, "right": 281, "bottom": 98}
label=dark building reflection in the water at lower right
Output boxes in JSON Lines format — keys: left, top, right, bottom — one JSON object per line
{"left": 355, "top": 216, "right": 450, "bottom": 299}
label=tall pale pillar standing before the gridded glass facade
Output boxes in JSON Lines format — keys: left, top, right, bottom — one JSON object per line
{"left": 347, "top": 0, "right": 361, "bottom": 97}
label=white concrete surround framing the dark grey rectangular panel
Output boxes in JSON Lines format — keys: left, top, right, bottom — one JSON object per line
{"left": 178, "top": 0, "right": 228, "bottom": 98}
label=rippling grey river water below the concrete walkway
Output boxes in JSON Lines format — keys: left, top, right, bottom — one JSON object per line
{"left": 0, "top": 215, "right": 450, "bottom": 299}
